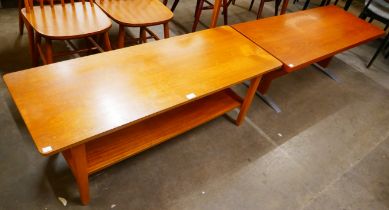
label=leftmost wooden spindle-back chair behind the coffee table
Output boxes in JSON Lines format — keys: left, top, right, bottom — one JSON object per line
{"left": 21, "top": 0, "right": 112, "bottom": 65}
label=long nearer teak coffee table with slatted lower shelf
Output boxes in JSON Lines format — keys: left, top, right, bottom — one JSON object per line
{"left": 4, "top": 26, "right": 282, "bottom": 204}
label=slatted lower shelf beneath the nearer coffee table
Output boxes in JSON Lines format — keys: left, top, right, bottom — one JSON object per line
{"left": 86, "top": 89, "right": 242, "bottom": 174}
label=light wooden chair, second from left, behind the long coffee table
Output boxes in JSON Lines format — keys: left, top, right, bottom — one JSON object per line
{"left": 96, "top": 0, "right": 173, "bottom": 48}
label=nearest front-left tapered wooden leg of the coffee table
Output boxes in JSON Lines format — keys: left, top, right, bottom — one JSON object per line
{"left": 62, "top": 144, "right": 90, "bottom": 205}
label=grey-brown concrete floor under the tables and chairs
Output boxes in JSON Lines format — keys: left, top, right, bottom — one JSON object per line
{"left": 0, "top": 0, "right": 389, "bottom": 210}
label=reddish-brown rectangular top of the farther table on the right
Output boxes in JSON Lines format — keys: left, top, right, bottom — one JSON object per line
{"left": 232, "top": 6, "right": 384, "bottom": 71}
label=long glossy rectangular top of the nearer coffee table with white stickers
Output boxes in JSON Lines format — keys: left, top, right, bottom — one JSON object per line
{"left": 4, "top": 26, "right": 282, "bottom": 155}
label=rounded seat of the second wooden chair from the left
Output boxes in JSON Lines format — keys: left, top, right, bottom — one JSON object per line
{"left": 96, "top": 0, "right": 173, "bottom": 27}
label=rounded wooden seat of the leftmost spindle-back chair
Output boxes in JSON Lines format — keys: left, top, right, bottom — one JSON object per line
{"left": 22, "top": 2, "right": 112, "bottom": 39}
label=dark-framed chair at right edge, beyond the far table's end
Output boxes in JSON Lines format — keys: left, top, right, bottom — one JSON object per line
{"left": 359, "top": 0, "right": 389, "bottom": 68}
